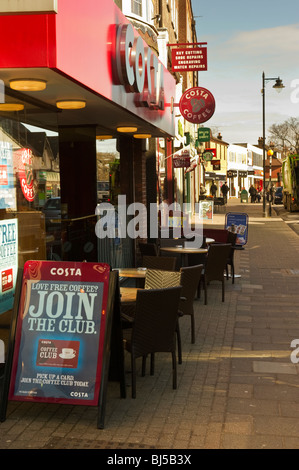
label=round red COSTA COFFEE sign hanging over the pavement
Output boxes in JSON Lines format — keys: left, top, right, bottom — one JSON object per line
{"left": 179, "top": 87, "right": 215, "bottom": 124}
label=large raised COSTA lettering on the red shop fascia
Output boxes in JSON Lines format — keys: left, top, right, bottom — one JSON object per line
{"left": 115, "top": 24, "right": 164, "bottom": 110}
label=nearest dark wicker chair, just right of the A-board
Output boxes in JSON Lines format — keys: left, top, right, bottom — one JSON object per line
{"left": 125, "top": 286, "right": 181, "bottom": 398}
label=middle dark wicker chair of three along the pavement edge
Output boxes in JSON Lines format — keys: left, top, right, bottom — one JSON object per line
{"left": 179, "top": 264, "right": 203, "bottom": 344}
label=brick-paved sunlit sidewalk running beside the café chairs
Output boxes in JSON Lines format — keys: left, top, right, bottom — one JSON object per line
{"left": 0, "top": 200, "right": 299, "bottom": 449}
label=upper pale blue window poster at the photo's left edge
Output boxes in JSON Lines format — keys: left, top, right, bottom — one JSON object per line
{"left": 0, "top": 141, "right": 17, "bottom": 210}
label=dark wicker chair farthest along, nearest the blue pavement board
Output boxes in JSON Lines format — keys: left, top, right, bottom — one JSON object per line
{"left": 198, "top": 243, "right": 231, "bottom": 305}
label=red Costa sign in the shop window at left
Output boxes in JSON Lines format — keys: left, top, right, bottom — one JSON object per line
{"left": 15, "top": 148, "right": 35, "bottom": 202}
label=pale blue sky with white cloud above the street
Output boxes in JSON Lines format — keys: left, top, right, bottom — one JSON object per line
{"left": 192, "top": 0, "right": 299, "bottom": 144}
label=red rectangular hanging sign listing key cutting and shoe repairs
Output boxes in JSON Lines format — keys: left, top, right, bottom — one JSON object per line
{"left": 171, "top": 44, "right": 208, "bottom": 72}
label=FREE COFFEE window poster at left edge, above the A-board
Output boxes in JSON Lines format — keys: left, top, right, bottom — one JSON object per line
{"left": 0, "top": 219, "right": 18, "bottom": 315}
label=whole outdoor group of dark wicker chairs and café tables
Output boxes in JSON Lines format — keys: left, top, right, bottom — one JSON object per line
{"left": 116, "top": 228, "right": 237, "bottom": 398}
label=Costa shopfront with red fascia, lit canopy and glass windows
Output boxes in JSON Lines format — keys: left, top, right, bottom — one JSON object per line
{"left": 0, "top": 0, "right": 175, "bottom": 277}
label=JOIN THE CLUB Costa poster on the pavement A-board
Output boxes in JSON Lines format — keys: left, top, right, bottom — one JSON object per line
{"left": 9, "top": 261, "right": 110, "bottom": 405}
